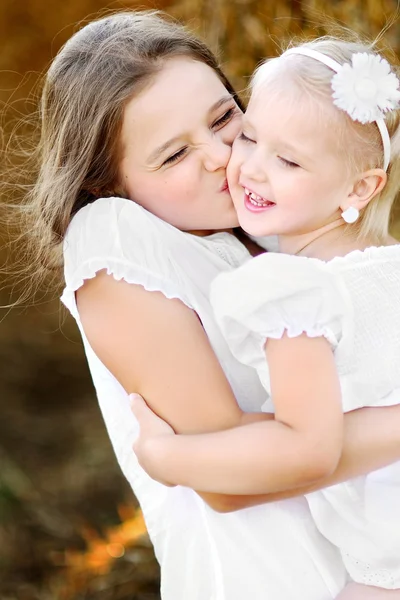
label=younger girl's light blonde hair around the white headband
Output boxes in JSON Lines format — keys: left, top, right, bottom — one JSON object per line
{"left": 251, "top": 36, "right": 400, "bottom": 241}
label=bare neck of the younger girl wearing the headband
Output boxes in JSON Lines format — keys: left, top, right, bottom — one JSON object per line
{"left": 279, "top": 218, "right": 354, "bottom": 258}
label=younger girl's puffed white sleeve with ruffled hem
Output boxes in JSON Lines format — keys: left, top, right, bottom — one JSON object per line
{"left": 211, "top": 253, "right": 352, "bottom": 376}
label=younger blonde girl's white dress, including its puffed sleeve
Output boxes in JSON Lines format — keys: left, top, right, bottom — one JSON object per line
{"left": 211, "top": 245, "right": 400, "bottom": 589}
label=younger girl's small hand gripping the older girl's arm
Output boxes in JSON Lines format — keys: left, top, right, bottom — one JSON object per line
{"left": 129, "top": 394, "right": 175, "bottom": 487}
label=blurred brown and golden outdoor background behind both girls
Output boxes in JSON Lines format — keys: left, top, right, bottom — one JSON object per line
{"left": 0, "top": 0, "right": 400, "bottom": 600}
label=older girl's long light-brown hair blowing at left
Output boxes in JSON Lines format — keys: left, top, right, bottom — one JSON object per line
{"left": 2, "top": 11, "right": 241, "bottom": 295}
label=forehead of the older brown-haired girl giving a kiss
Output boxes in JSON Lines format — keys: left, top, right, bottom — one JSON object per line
{"left": 121, "top": 57, "right": 227, "bottom": 156}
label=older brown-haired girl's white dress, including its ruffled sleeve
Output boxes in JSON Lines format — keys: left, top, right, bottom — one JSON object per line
{"left": 62, "top": 198, "right": 346, "bottom": 600}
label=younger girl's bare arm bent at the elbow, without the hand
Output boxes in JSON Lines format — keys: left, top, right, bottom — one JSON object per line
{"left": 132, "top": 334, "right": 343, "bottom": 494}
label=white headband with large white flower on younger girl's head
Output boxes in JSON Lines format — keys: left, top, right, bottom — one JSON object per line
{"left": 282, "top": 47, "right": 400, "bottom": 171}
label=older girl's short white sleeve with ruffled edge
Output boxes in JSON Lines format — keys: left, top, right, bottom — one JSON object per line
{"left": 61, "top": 198, "right": 192, "bottom": 318}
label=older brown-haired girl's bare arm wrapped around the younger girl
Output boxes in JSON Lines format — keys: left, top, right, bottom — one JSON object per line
{"left": 77, "top": 273, "right": 400, "bottom": 512}
